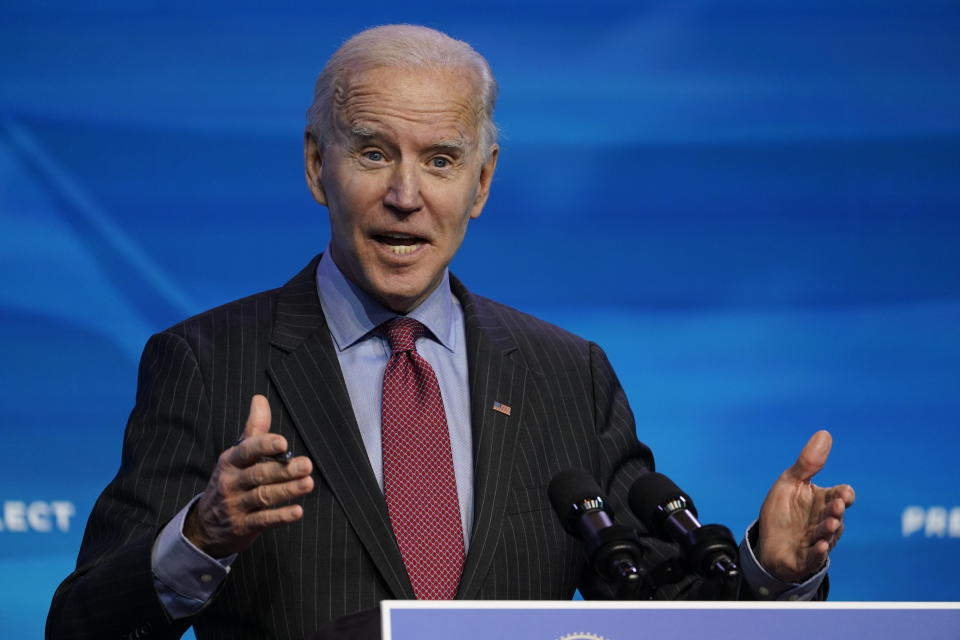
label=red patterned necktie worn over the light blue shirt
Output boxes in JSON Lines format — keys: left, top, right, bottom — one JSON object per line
{"left": 381, "top": 317, "right": 464, "bottom": 600}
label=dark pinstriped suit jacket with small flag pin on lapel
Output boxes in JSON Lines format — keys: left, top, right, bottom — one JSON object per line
{"left": 47, "top": 259, "right": 694, "bottom": 639}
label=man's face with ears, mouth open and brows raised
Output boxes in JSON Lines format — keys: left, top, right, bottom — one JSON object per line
{"left": 305, "top": 68, "right": 497, "bottom": 313}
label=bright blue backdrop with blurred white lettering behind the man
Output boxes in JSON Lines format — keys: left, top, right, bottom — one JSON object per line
{"left": 0, "top": 0, "right": 960, "bottom": 638}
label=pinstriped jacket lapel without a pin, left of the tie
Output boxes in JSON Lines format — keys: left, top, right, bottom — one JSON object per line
{"left": 268, "top": 258, "right": 413, "bottom": 598}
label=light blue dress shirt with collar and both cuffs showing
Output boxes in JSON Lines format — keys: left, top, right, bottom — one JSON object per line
{"left": 152, "top": 251, "right": 829, "bottom": 619}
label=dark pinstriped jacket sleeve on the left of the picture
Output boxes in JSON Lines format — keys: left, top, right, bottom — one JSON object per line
{"left": 46, "top": 332, "right": 219, "bottom": 640}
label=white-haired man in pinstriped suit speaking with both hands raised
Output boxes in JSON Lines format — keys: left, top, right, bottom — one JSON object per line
{"left": 47, "top": 26, "right": 853, "bottom": 638}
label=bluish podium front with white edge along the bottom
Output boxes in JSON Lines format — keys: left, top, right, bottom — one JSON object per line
{"left": 382, "top": 601, "right": 960, "bottom": 640}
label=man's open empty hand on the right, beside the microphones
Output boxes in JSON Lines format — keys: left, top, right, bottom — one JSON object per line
{"left": 755, "top": 431, "right": 855, "bottom": 582}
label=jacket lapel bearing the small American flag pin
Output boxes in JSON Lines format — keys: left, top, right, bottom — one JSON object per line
{"left": 451, "top": 277, "right": 527, "bottom": 599}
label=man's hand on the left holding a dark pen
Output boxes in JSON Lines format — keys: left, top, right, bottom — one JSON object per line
{"left": 183, "top": 395, "right": 313, "bottom": 558}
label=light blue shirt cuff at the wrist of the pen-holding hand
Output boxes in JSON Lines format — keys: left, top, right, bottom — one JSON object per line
{"left": 150, "top": 495, "right": 237, "bottom": 620}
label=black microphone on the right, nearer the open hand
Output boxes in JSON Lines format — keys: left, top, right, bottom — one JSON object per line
{"left": 629, "top": 471, "right": 740, "bottom": 584}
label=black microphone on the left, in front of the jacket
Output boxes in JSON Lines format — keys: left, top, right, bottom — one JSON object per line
{"left": 547, "top": 469, "right": 649, "bottom": 592}
